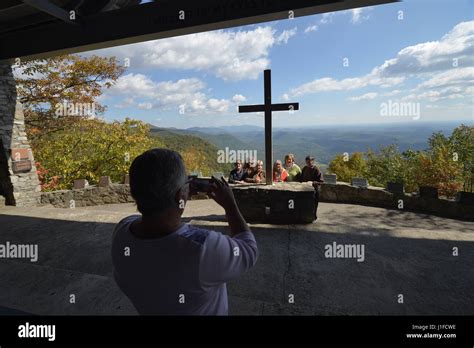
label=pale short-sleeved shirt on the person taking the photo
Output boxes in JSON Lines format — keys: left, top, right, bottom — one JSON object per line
{"left": 112, "top": 215, "right": 258, "bottom": 315}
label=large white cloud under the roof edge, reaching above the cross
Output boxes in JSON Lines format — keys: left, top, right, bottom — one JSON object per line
{"left": 87, "top": 26, "right": 297, "bottom": 80}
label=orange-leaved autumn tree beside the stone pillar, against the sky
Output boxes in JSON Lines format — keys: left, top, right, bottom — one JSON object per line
{"left": 14, "top": 55, "right": 124, "bottom": 140}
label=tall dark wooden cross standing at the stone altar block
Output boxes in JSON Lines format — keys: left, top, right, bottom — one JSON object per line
{"left": 239, "top": 70, "right": 300, "bottom": 185}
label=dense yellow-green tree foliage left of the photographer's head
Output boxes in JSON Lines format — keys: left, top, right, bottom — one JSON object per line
{"left": 32, "top": 119, "right": 153, "bottom": 190}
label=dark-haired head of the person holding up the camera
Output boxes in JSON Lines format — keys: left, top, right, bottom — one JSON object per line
{"left": 129, "top": 148, "right": 186, "bottom": 215}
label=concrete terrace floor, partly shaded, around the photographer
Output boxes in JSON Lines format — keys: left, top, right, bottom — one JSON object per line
{"left": 0, "top": 200, "right": 474, "bottom": 315}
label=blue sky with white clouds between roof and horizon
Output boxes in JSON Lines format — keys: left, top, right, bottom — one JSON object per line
{"left": 87, "top": 0, "right": 474, "bottom": 128}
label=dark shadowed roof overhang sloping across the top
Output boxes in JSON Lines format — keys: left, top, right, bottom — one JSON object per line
{"left": 0, "top": 0, "right": 397, "bottom": 62}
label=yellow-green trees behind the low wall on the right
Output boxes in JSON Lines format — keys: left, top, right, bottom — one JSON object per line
{"left": 329, "top": 125, "right": 474, "bottom": 197}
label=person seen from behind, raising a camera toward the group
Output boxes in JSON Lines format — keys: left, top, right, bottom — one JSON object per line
{"left": 112, "top": 149, "right": 258, "bottom": 315}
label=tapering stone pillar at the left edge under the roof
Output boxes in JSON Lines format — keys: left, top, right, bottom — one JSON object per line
{"left": 0, "top": 64, "right": 41, "bottom": 206}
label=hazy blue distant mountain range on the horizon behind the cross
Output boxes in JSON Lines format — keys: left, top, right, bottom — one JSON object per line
{"left": 150, "top": 122, "right": 472, "bottom": 168}
